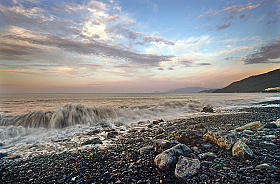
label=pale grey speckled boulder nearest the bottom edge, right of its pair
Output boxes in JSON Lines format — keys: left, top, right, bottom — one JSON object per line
{"left": 175, "top": 156, "right": 200, "bottom": 180}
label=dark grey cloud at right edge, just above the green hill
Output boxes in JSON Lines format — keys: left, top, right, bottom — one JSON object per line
{"left": 243, "top": 41, "right": 280, "bottom": 64}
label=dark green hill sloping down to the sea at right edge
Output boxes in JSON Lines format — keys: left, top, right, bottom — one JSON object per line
{"left": 213, "top": 69, "right": 280, "bottom": 93}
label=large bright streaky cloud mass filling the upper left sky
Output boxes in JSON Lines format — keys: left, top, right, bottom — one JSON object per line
{"left": 0, "top": 1, "right": 174, "bottom": 67}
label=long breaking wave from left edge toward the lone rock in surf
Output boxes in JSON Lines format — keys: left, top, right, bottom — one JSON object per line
{"left": 1, "top": 102, "right": 201, "bottom": 128}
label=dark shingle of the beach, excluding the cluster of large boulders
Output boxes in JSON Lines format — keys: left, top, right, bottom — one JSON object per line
{"left": 0, "top": 101, "right": 280, "bottom": 183}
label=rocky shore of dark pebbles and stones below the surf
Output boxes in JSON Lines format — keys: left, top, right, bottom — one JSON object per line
{"left": 0, "top": 104, "right": 280, "bottom": 184}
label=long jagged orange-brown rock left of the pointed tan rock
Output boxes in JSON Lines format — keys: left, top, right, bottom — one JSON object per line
{"left": 203, "top": 130, "right": 237, "bottom": 149}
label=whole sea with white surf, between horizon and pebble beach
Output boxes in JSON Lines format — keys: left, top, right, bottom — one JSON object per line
{"left": 0, "top": 93, "right": 280, "bottom": 159}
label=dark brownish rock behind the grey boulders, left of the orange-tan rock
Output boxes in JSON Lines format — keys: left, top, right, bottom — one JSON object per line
{"left": 174, "top": 130, "right": 205, "bottom": 144}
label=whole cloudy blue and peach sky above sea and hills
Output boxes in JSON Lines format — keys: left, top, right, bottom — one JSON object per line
{"left": 0, "top": 0, "right": 280, "bottom": 93}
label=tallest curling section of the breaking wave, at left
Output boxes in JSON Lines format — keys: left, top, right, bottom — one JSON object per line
{"left": 1, "top": 104, "right": 124, "bottom": 128}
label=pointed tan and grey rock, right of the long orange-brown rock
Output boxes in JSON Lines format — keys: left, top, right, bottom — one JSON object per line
{"left": 232, "top": 139, "right": 253, "bottom": 158}
